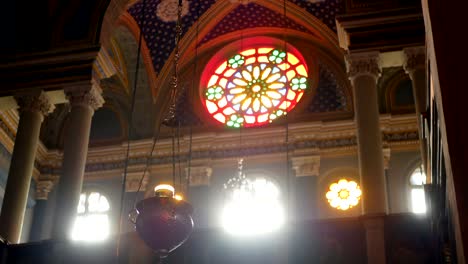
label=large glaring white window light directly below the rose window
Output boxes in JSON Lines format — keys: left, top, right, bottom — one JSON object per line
{"left": 222, "top": 178, "right": 285, "bottom": 236}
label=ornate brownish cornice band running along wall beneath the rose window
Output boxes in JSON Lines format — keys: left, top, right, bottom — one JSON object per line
{"left": 32, "top": 114, "right": 419, "bottom": 178}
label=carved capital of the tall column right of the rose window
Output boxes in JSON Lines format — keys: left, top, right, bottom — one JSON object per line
{"left": 345, "top": 52, "right": 382, "bottom": 80}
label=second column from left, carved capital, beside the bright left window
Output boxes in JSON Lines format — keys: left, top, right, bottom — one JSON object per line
{"left": 52, "top": 83, "right": 104, "bottom": 240}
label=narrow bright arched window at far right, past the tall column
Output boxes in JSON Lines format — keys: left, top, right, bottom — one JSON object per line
{"left": 410, "top": 167, "right": 426, "bottom": 214}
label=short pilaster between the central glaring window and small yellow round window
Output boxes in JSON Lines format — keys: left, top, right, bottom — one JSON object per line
{"left": 292, "top": 156, "right": 320, "bottom": 222}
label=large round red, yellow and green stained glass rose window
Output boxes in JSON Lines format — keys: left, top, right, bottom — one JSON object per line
{"left": 203, "top": 47, "right": 308, "bottom": 128}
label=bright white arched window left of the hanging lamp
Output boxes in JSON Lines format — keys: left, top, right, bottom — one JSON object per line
{"left": 72, "top": 191, "right": 110, "bottom": 241}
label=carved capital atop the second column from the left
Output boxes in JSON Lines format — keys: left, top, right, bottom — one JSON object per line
{"left": 64, "top": 81, "right": 104, "bottom": 110}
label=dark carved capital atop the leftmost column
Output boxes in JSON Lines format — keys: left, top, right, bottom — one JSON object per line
{"left": 15, "top": 92, "right": 55, "bottom": 116}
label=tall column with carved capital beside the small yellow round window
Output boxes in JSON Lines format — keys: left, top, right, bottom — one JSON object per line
{"left": 346, "top": 52, "right": 387, "bottom": 264}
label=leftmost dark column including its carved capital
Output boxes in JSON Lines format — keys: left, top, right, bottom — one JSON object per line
{"left": 0, "top": 92, "right": 53, "bottom": 243}
